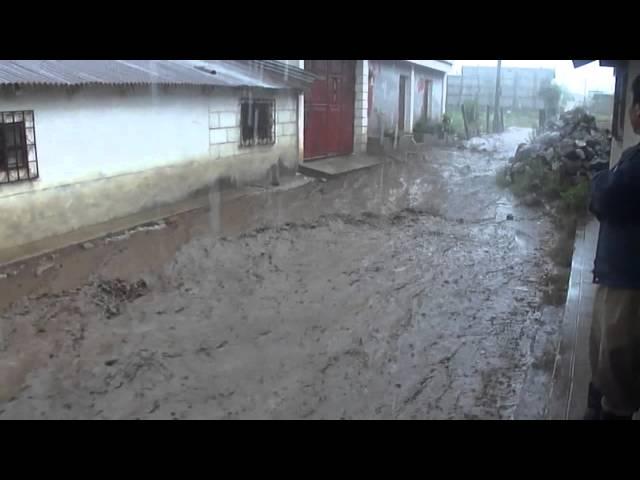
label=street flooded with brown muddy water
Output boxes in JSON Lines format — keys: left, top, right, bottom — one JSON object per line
{"left": 0, "top": 130, "right": 558, "bottom": 419}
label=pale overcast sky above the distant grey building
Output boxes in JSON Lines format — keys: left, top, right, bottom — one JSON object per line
{"left": 451, "top": 60, "right": 615, "bottom": 95}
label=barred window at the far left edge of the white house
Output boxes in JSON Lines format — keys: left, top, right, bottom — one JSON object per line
{"left": 0, "top": 110, "right": 38, "bottom": 184}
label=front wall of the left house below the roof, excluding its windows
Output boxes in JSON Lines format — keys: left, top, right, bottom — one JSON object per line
{"left": 0, "top": 87, "right": 298, "bottom": 253}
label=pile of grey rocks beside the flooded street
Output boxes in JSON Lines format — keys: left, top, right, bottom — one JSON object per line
{"left": 508, "top": 108, "right": 611, "bottom": 180}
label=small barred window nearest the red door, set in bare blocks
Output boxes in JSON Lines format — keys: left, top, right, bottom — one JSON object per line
{"left": 240, "top": 99, "right": 276, "bottom": 147}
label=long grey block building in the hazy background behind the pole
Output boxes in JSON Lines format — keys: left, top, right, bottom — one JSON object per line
{"left": 446, "top": 66, "right": 555, "bottom": 110}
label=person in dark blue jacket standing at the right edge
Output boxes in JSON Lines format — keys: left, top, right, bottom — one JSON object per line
{"left": 585, "top": 72, "right": 640, "bottom": 420}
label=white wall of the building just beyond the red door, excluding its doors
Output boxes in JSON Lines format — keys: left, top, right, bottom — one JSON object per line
{"left": 368, "top": 60, "right": 445, "bottom": 138}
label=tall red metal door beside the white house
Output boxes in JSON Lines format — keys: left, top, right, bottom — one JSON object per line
{"left": 304, "top": 60, "right": 355, "bottom": 159}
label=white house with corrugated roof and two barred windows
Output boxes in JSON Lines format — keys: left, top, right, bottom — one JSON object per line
{"left": 0, "top": 60, "right": 314, "bottom": 249}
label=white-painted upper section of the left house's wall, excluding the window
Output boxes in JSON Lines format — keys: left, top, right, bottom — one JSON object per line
{"left": 0, "top": 88, "right": 209, "bottom": 198}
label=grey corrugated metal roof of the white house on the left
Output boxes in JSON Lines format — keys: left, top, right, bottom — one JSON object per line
{"left": 0, "top": 60, "right": 312, "bottom": 89}
